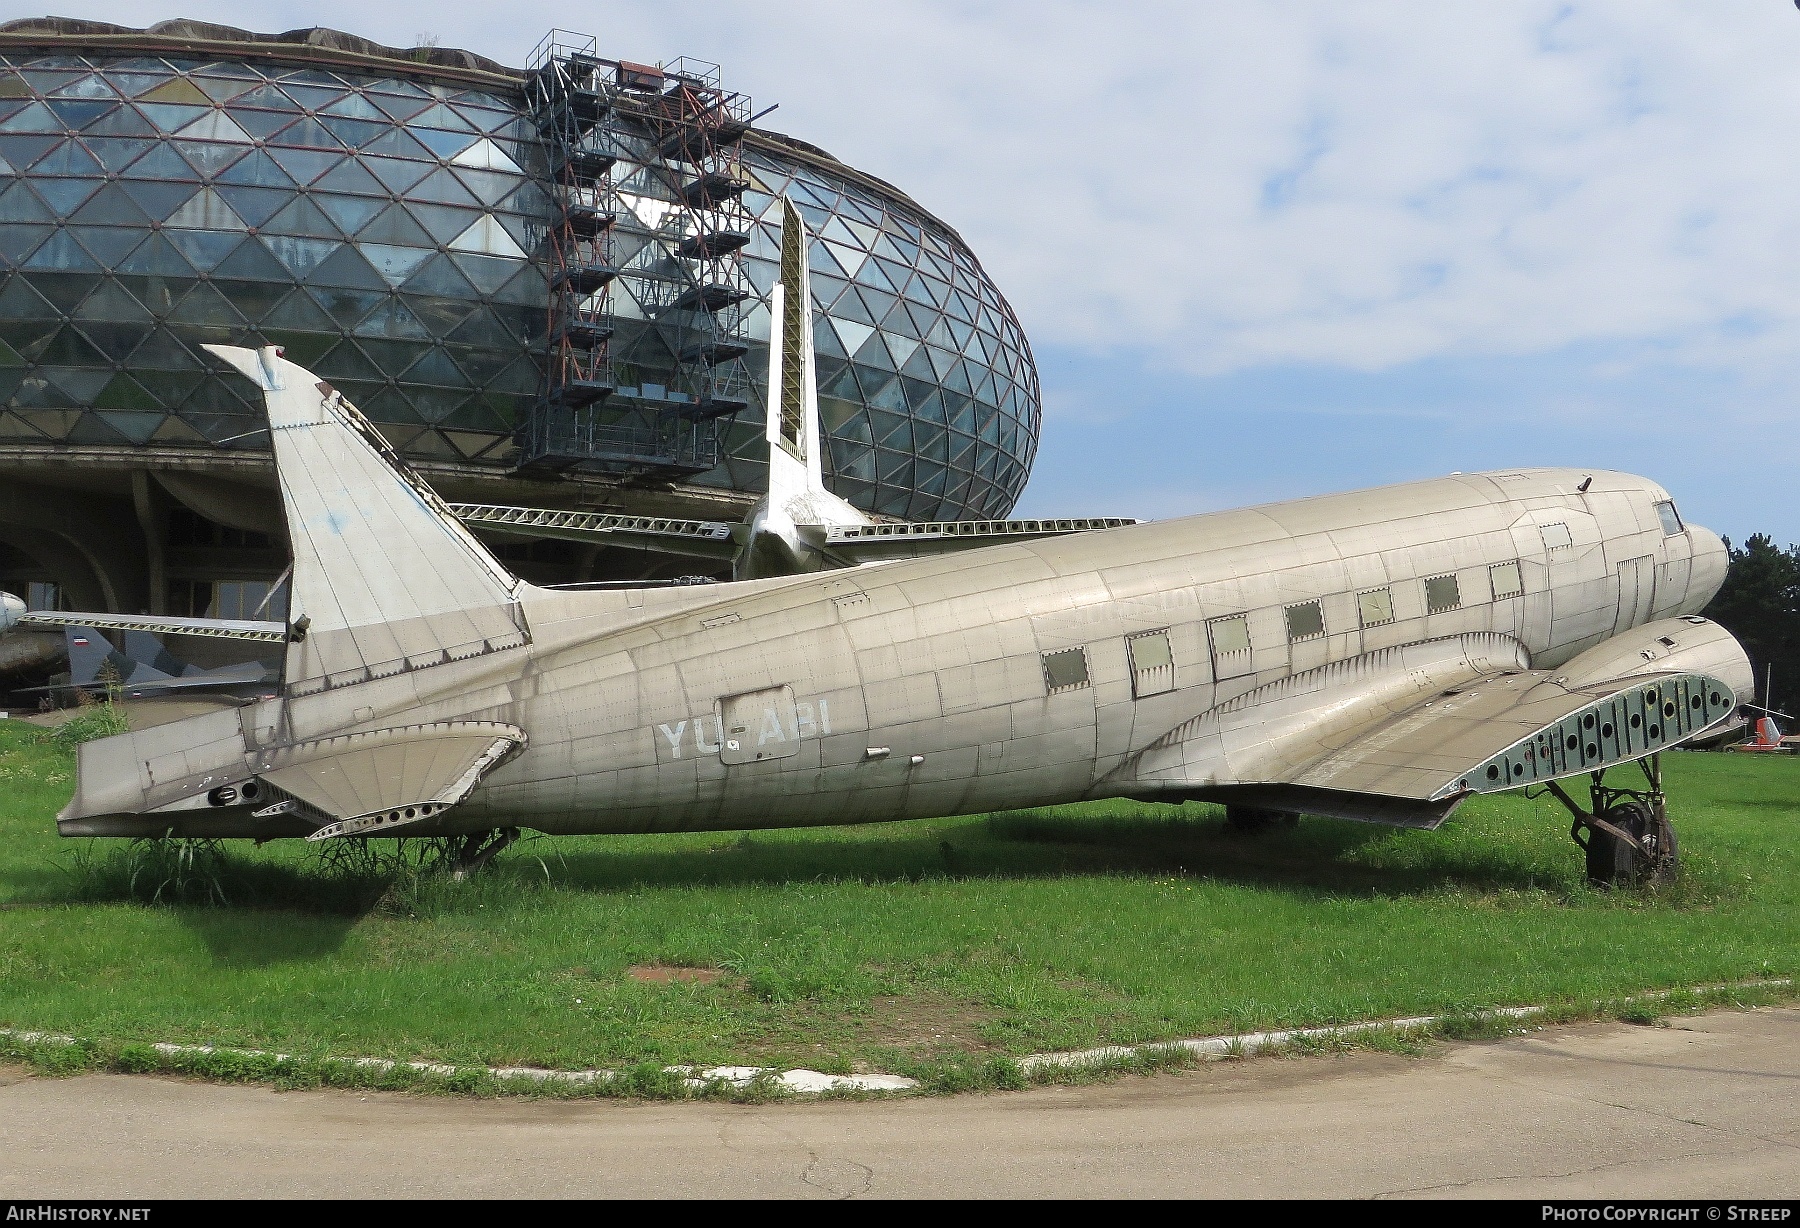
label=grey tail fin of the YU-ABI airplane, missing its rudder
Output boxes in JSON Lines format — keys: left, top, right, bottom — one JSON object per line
{"left": 207, "top": 346, "right": 527, "bottom": 695}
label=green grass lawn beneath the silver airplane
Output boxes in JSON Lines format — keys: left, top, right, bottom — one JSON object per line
{"left": 0, "top": 724, "right": 1800, "bottom": 1088}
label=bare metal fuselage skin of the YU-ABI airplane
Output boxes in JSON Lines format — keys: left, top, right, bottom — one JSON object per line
{"left": 61, "top": 470, "right": 1750, "bottom": 835}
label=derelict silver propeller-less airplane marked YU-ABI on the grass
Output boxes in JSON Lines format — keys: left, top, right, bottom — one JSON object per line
{"left": 17, "top": 329, "right": 1753, "bottom": 884}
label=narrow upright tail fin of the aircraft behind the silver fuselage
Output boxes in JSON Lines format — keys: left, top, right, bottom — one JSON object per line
{"left": 765, "top": 198, "right": 869, "bottom": 524}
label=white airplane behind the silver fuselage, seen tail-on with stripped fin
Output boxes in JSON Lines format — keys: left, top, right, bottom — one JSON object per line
{"left": 450, "top": 198, "right": 1138, "bottom": 580}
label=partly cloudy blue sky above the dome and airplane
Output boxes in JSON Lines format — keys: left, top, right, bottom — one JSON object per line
{"left": 24, "top": 0, "right": 1800, "bottom": 542}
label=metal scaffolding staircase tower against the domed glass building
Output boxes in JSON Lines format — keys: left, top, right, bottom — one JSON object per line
{"left": 520, "top": 31, "right": 756, "bottom": 481}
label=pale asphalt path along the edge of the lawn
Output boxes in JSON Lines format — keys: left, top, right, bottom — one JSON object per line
{"left": 0, "top": 1008, "right": 1800, "bottom": 1199}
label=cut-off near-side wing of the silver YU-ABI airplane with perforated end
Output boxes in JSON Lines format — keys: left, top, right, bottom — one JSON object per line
{"left": 1109, "top": 619, "right": 1737, "bottom": 826}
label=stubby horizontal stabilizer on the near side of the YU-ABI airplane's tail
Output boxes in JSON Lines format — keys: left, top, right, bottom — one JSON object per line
{"left": 239, "top": 720, "right": 526, "bottom": 839}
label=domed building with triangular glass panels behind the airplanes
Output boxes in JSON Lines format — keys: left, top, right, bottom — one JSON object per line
{"left": 0, "top": 20, "right": 1039, "bottom": 605}
